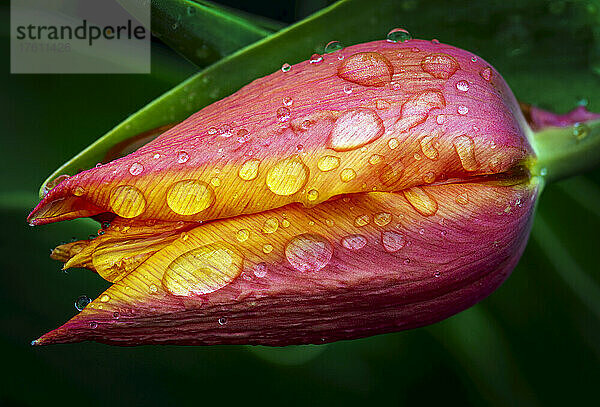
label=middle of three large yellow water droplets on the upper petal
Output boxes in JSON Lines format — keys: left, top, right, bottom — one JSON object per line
{"left": 167, "top": 180, "right": 215, "bottom": 215}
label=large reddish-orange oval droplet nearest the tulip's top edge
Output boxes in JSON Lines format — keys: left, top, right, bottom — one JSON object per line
{"left": 338, "top": 52, "right": 394, "bottom": 87}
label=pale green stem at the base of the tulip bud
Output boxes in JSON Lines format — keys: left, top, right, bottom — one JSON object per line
{"left": 531, "top": 120, "right": 600, "bottom": 182}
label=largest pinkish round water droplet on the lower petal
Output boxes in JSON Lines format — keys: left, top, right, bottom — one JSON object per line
{"left": 285, "top": 233, "right": 333, "bottom": 272}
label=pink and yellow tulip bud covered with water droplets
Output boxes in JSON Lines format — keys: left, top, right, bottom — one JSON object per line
{"left": 29, "top": 40, "right": 584, "bottom": 345}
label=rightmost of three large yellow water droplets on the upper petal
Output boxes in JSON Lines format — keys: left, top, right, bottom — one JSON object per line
{"left": 266, "top": 156, "right": 309, "bottom": 196}
